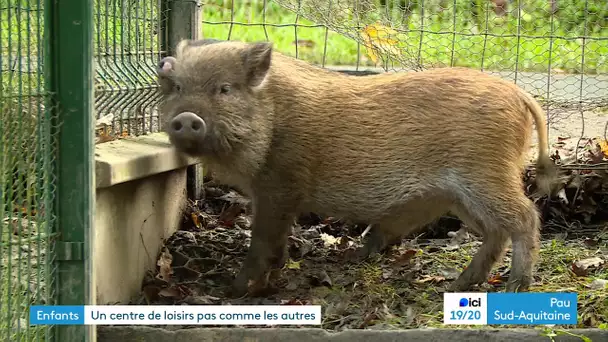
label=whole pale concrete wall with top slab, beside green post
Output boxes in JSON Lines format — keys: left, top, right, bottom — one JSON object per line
{"left": 91, "top": 133, "right": 198, "bottom": 305}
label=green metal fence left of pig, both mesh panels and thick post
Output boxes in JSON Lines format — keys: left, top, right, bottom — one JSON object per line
{"left": 0, "top": 0, "right": 178, "bottom": 341}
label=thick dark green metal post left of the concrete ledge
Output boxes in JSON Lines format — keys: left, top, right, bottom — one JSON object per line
{"left": 45, "top": 0, "right": 95, "bottom": 342}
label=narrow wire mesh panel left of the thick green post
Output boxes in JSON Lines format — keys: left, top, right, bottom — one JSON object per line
{"left": 0, "top": 0, "right": 56, "bottom": 341}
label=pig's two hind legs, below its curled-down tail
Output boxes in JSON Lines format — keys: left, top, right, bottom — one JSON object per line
{"left": 450, "top": 188, "right": 540, "bottom": 292}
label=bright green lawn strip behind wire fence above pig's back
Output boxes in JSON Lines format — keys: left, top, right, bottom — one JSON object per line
{"left": 202, "top": 0, "right": 608, "bottom": 73}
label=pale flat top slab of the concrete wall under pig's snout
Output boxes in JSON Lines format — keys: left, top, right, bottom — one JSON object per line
{"left": 95, "top": 133, "right": 199, "bottom": 188}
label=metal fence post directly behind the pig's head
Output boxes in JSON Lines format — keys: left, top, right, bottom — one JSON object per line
{"left": 161, "top": 0, "right": 204, "bottom": 199}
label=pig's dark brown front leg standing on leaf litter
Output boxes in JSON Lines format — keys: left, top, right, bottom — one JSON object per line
{"left": 232, "top": 194, "right": 296, "bottom": 297}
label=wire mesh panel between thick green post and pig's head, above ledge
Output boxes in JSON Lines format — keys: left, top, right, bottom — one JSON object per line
{"left": 94, "top": 0, "right": 166, "bottom": 142}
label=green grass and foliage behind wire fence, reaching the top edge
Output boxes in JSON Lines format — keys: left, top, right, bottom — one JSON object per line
{"left": 202, "top": 0, "right": 608, "bottom": 73}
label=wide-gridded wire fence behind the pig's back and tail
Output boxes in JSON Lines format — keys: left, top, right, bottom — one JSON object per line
{"left": 202, "top": 0, "right": 608, "bottom": 167}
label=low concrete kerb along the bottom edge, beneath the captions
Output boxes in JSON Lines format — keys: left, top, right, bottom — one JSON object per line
{"left": 97, "top": 326, "right": 608, "bottom": 342}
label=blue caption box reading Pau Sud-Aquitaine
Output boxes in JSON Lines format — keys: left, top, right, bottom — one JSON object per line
{"left": 487, "top": 292, "right": 578, "bottom": 325}
